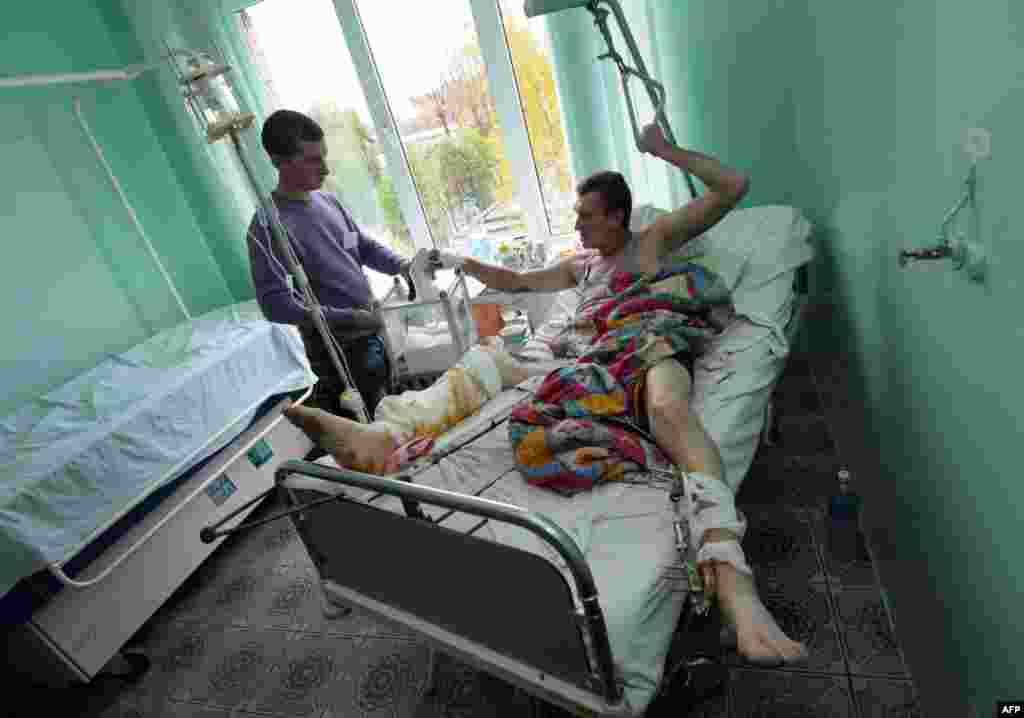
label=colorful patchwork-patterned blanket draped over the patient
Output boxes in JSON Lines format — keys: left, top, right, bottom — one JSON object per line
{"left": 509, "top": 262, "right": 732, "bottom": 494}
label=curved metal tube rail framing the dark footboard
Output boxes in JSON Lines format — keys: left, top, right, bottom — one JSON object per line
{"left": 274, "top": 459, "right": 623, "bottom": 704}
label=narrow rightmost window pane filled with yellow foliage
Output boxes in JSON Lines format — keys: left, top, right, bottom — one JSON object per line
{"left": 501, "top": 0, "right": 575, "bottom": 236}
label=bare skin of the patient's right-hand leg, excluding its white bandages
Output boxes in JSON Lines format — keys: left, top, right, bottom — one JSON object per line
{"left": 645, "top": 360, "right": 807, "bottom": 664}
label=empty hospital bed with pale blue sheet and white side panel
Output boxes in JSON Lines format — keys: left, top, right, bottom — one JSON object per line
{"left": 0, "top": 302, "right": 316, "bottom": 686}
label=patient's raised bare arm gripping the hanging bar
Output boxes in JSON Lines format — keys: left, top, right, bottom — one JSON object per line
{"left": 641, "top": 125, "right": 751, "bottom": 249}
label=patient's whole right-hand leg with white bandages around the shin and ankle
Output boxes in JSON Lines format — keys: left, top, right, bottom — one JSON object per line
{"left": 644, "top": 360, "right": 807, "bottom": 665}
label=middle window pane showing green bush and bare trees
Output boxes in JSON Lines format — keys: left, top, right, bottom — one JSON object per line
{"left": 356, "top": 0, "right": 543, "bottom": 266}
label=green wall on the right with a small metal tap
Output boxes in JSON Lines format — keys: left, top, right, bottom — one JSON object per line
{"left": 630, "top": 0, "right": 1024, "bottom": 716}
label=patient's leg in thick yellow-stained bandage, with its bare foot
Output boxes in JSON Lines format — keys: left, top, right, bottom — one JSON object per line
{"left": 285, "top": 342, "right": 529, "bottom": 474}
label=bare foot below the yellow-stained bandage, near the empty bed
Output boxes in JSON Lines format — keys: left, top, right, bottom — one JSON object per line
{"left": 285, "top": 405, "right": 397, "bottom": 474}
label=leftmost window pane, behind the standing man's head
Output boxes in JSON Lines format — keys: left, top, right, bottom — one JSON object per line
{"left": 239, "top": 0, "right": 416, "bottom": 296}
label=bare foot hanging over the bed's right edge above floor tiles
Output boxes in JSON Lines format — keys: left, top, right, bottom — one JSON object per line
{"left": 715, "top": 563, "right": 808, "bottom": 666}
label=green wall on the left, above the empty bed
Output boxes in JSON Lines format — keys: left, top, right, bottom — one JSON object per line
{"left": 0, "top": 0, "right": 274, "bottom": 416}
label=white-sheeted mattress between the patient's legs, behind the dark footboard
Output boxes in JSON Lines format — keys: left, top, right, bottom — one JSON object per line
{"left": 303, "top": 378, "right": 685, "bottom": 715}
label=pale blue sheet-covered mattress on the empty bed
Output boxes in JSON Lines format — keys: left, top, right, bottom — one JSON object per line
{"left": 0, "top": 302, "right": 316, "bottom": 595}
